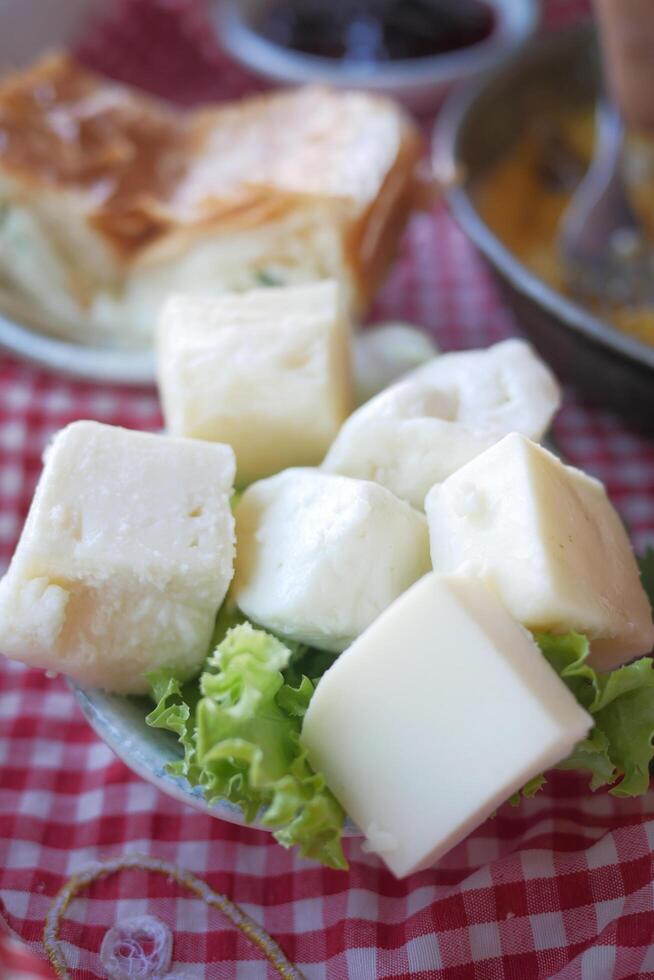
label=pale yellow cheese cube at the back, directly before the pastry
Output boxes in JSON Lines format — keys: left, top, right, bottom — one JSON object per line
{"left": 157, "top": 281, "right": 352, "bottom": 485}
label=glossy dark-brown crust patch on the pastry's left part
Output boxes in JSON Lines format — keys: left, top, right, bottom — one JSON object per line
{"left": 0, "top": 55, "right": 190, "bottom": 252}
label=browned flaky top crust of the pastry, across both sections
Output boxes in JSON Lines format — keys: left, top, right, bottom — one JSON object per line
{"left": 0, "top": 55, "right": 421, "bottom": 294}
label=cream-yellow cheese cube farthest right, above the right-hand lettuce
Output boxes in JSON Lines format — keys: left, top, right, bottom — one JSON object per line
{"left": 426, "top": 433, "right": 654, "bottom": 670}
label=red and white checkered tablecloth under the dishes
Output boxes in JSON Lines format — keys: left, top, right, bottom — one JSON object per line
{"left": 0, "top": 0, "right": 654, "bottom": 980}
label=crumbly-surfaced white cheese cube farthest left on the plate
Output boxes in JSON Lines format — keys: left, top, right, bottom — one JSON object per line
{"left": 0, "top": 422, "right": 236, "bottom": 694}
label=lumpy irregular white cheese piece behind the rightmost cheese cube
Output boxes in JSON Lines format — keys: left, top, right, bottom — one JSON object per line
{"left": 323, "top": 340, "right": 560, "bottom": 508}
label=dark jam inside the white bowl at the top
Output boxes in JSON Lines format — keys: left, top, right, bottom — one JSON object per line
{"left": 255, "top": 0, "right": 495, "bottom": 63}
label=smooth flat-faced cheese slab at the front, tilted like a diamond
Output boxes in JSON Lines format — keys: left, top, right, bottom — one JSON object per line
{"left": 302, "top": 573, "right": 592, "bottom": 878}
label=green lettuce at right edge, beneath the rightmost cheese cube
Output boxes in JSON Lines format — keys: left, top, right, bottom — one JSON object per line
{"left": 525, "top": 633, "right": 654, "bottom": 796}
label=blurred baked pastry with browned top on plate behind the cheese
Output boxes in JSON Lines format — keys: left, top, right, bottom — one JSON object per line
{"left": 0, "top": 54, "right": 421, "bottom": 346}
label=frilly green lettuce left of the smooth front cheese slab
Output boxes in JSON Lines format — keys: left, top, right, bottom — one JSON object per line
{"left": 146, "top": 624, "right": 347, "bottom": 868}
